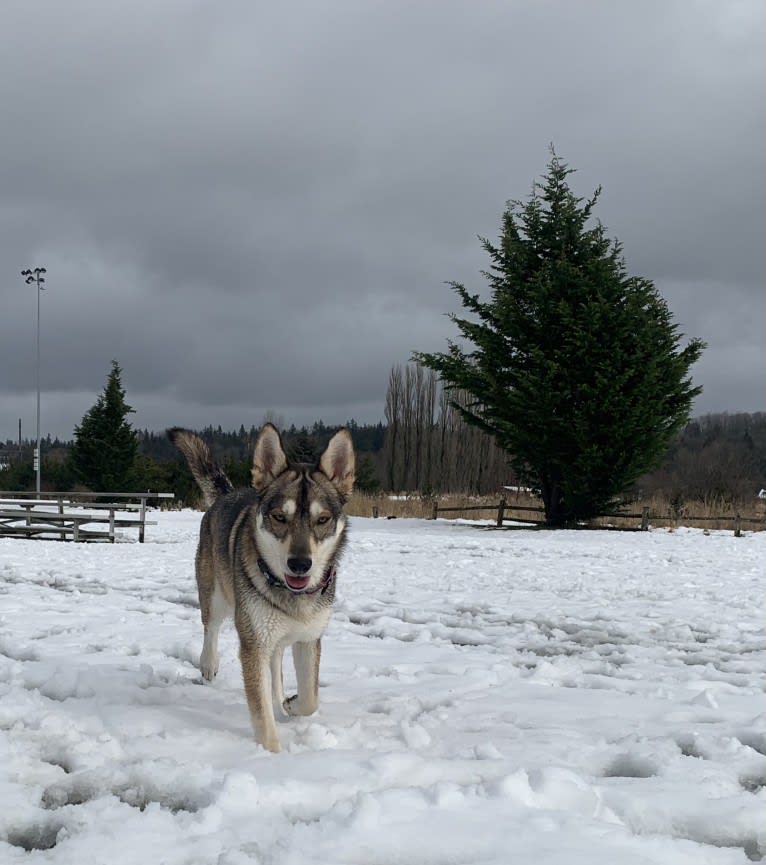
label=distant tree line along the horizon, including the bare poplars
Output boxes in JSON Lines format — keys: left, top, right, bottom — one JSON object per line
{"left": 0, "top": 363, "right": 766, "bottom": 507}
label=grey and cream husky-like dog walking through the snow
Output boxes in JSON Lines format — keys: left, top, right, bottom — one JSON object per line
{"left": 167, "top": 423, "right": 355, "bottom": 752}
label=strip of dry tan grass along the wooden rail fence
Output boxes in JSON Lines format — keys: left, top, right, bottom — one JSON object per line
{"left": 347, "top": 493, "right": 766, "bottom": 531}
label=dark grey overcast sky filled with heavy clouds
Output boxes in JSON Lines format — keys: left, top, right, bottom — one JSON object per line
{"left": 0, "top": 0, "right": 766, "bottom": 440}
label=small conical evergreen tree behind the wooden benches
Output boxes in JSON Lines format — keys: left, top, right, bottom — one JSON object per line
{"left": 69, "top": 360, "right": 138, "bottom": 493}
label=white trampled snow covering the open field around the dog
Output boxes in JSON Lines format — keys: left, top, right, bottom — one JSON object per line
{"left": 0, "top": 511, "right": 766, "bottom": 865}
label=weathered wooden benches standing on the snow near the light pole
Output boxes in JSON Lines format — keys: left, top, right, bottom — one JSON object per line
{"left": 0, "top": 492, "right": 175, "bottom": 544}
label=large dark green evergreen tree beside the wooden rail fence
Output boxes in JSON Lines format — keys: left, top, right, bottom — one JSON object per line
{"left": 414, "top": 152, "right": 704, "bottom": 526}
